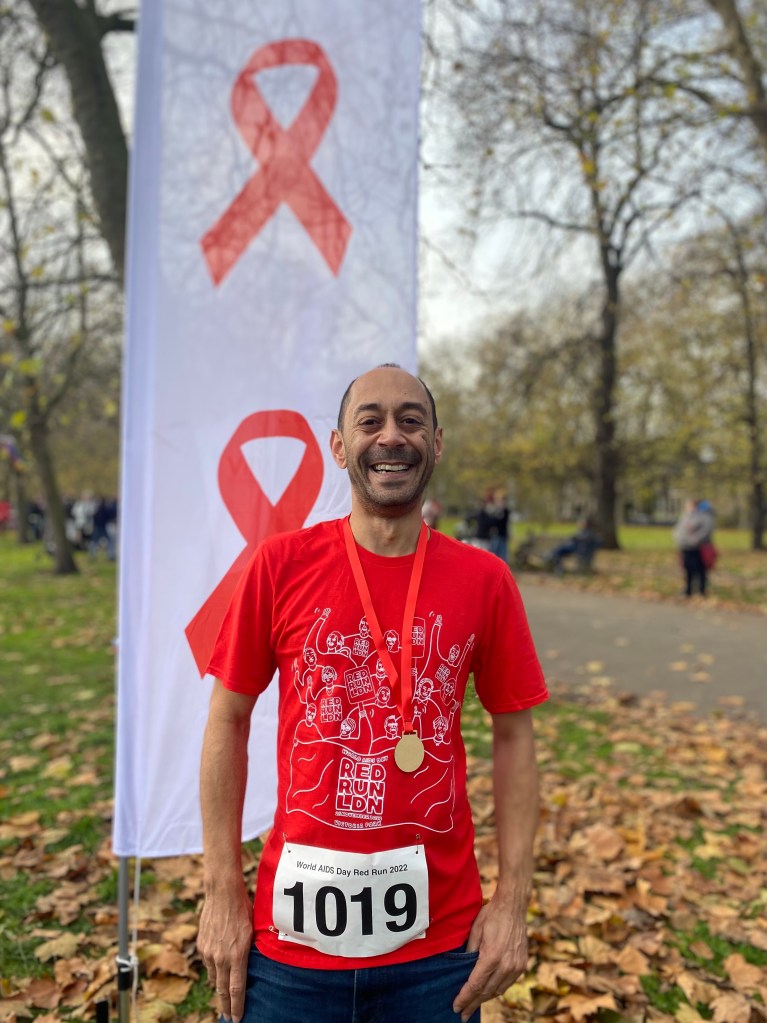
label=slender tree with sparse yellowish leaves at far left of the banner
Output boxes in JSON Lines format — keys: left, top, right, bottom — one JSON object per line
{"left": 0, "top": 7, "right": 119, "bottom": 574}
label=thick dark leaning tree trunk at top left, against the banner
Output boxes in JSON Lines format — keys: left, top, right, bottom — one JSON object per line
{"left": 30, "top": 0, "right": 128, "bottom": 279}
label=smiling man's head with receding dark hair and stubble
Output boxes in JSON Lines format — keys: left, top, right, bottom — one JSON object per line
{"left": 330, "top": 367, "right": 442, "bottom": 510}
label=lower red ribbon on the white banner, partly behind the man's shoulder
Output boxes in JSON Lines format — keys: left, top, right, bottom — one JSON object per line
{"left": 185, "top": 409, "right": 323, "bottom": 675}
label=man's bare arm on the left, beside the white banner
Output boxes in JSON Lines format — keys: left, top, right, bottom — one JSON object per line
{"left": 197, "top": 679, "right": 256, "bottom": 1021}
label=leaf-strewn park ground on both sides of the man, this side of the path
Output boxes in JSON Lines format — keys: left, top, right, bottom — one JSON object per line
{"left": 0, "top": 550, "right": 767, "bottom": 1023}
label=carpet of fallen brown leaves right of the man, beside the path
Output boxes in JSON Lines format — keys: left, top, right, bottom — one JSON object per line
{"left": 472, "top": 679, "right": 767, "bottom": 1023}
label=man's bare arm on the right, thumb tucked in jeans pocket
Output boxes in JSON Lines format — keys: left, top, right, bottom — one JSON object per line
{"left": 453, "top": 710, "right": 538, "bottom": 1023}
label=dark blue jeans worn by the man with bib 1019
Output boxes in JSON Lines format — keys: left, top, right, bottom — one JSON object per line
{"left": 230, "top": 948, "right": 480, "bottom": 1023}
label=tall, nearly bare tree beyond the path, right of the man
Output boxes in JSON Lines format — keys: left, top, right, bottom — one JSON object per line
{"left": 441, "top": 0, "right": 760, "bottom": 546}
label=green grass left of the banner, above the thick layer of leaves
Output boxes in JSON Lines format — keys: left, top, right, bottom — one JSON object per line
{"left": 0, "top": 536, "right": 115, "bottom": 830}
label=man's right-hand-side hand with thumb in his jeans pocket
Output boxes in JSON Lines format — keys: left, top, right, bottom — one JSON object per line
{"left": 453, "top": 892, "right": 528, "bottom": 1023}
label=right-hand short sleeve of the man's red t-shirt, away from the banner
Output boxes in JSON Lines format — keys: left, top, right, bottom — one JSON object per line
{"left": 473, "top": 570, "right": 548, "bottom": 714}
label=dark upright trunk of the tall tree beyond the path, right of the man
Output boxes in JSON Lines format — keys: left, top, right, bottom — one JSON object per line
{"left": 593, "top": 263, "right": 621, "bottom": 550}
